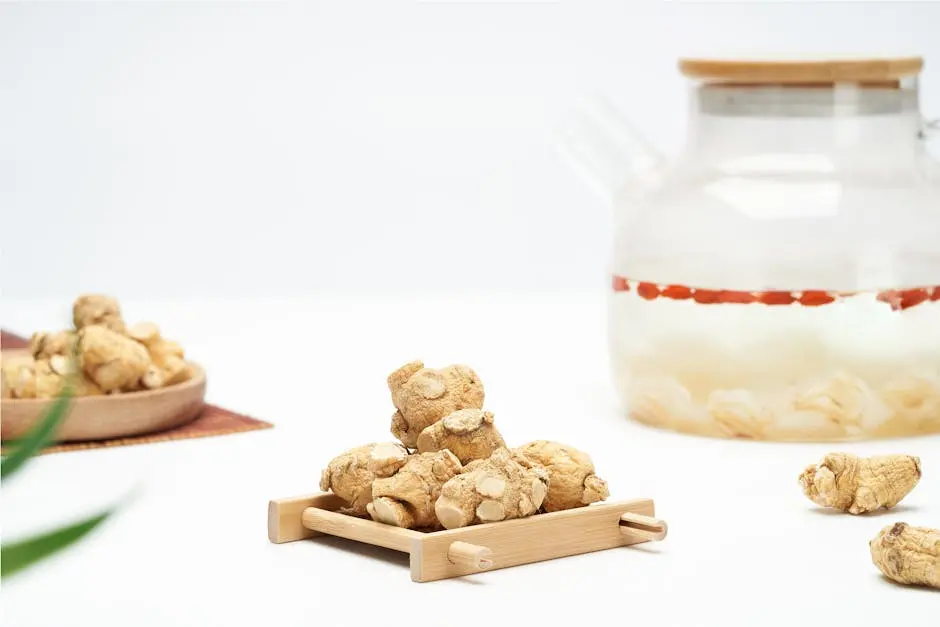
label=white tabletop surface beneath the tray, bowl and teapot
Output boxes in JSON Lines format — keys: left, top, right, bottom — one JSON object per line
{"left": 0, "top": 294, "right": 940, "bottom": 627}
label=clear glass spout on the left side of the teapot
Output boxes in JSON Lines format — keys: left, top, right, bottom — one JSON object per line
{"left": 555, "top": 95, "right": 663, "bottom": 200}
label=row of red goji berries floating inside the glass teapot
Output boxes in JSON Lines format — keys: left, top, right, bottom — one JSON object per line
{"left": 612, "top": 275, "right": 940, "bottom": 311}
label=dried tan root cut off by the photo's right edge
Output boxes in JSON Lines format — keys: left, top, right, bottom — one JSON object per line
{"left": 868, "top": 522, "right": 940, "bottom": 588}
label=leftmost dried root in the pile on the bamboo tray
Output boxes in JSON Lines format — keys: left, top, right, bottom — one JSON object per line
{"left": 320, "top": 442, "right": 408, "bottom": 516}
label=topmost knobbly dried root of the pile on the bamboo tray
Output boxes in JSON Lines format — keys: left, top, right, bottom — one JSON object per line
{"left": 387, "top": 361, "right": 484, "bottom": 449}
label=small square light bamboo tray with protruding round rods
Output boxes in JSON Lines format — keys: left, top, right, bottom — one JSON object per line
{"left": 268, "top": 493, "right": 667, "bottom": 582}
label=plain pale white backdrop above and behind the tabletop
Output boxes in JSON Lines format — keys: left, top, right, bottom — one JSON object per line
{"left": 0, "top": 0, "right": 940, "bottom": 298}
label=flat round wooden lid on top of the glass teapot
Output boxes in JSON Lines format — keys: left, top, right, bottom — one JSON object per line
{"left": 679, "top": 57, "right": 924, "bottom": 85}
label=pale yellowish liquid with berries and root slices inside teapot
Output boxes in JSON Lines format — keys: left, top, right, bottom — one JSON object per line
{"left": 609, "top": 278, "right": 940, "bottom": 441}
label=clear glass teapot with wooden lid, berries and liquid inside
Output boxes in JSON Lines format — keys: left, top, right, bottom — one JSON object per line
{"left": 561, "top": 58, "right": 940, "bottom": 441}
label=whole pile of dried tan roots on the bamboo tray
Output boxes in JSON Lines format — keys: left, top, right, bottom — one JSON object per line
{"left": 320, "top": 361, "right": 610, "bottom": 531}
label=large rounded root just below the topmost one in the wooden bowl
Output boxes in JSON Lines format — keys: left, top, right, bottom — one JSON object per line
{"left": 79, "top": 325, "right": 152, "bottom": 393}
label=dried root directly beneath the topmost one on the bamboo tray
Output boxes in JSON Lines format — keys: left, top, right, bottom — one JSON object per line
{"left": 418, "top": 409, "right": 506, "bottom": 464}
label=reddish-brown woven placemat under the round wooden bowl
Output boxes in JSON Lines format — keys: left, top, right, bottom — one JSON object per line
{"left": 0, "top": 330, "right": 274, "bottom": 454}
